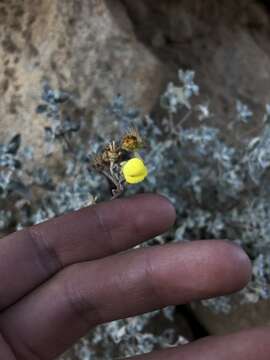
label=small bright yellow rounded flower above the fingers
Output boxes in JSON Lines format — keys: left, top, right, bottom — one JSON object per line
{"left": 122, "top": 158, "right": 148, "bottom": 184}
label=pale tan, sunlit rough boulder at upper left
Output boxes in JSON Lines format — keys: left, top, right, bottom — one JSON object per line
{"left": 0, "top": 0, "right": 161, "bottom": 160}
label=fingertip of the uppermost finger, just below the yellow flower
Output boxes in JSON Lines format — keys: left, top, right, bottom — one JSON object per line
{"left": 94, "top": 193, "right": 176, "bottom": 251}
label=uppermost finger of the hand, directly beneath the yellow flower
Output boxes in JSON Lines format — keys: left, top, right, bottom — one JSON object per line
{"left": 0, "top": 194, "right": 175, "bottom": 310}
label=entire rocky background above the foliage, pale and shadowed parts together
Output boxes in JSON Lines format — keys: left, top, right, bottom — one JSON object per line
{"left": 3, "top": 0, "right": 270, "bottom": 161}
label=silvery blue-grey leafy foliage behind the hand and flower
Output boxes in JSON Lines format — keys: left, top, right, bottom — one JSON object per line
{"left": 0, "top": 70, "right": 270, "bottom": 358}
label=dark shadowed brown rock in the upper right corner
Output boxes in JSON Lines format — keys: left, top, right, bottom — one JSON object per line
{"left": 122, "top": 0, "right": 270, "bottom": 122}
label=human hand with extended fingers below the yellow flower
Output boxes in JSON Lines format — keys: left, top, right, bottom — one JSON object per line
{"left": 0, "top": 195, "right": 270, "bottom": 360}
